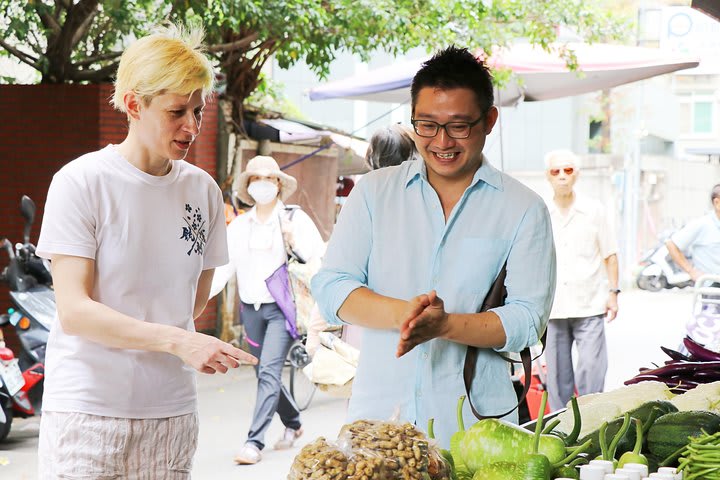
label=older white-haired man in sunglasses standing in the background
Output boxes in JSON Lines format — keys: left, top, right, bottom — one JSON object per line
{"left": 545, "top": 150, "right": 620, "bottom": 410}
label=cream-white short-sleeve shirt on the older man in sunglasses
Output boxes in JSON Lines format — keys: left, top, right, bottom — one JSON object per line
{"left": 547, "top": 196, "right": 617, "bottom": 318}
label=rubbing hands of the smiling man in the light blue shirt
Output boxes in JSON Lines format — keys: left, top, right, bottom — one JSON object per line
{"left": 396, "top": 290, "right": 450, "bottom": 358}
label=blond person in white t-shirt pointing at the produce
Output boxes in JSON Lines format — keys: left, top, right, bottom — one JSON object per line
{"left": 38, "top": 27, "right": 255, "bottom": 479}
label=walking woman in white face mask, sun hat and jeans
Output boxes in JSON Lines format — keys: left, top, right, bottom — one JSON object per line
{"left": 210, "top": 156, "right": 324, "bottom": 465}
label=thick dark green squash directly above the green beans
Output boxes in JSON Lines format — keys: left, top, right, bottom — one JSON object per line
{"left": 648, "top": 410, "right": 720, "bottom": 458}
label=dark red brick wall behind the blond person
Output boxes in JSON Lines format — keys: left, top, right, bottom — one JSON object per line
{"left": 0, "top": 85, "right": 218, "bottom": 342}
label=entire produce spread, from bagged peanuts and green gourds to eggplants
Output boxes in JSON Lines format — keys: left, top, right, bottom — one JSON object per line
{"left": 287, "top": 338, "right": 720, "bottom": 480}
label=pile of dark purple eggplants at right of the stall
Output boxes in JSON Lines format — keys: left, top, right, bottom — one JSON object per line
{"left": 625, "top": 337, "right": 720, "bottom": 393}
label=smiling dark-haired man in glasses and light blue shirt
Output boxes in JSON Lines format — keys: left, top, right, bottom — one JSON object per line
{"left": 312, "top": 47, "right": 555, "bottom": 447}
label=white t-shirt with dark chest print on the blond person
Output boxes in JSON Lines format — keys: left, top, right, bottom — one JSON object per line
{"left": 37, "top": 145, "right": 228, "bottom": 418}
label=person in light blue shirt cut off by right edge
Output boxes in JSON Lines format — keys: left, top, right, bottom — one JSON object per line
{"left": 665, "top": 183, "right": 720, "bottom": 280}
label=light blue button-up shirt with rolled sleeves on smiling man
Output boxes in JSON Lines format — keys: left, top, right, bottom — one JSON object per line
{"left": 312, "top": 159, "right": 555, "bottom": 447}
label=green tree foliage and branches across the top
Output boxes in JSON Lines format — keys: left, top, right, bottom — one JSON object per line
{"left": 0, "top": 0, "right": 624, "bottom": 129}
